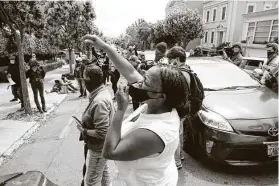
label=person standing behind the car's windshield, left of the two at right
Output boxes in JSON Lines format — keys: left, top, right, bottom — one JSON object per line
{"left": 223, "top": 43, "right": 243, "bottom": 66}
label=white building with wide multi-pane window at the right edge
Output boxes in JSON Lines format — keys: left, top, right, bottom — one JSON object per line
{"left": 241, "top": 1, "right": 278, "bottom": 57}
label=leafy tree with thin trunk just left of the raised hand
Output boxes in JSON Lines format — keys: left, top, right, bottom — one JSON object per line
{"left": 45, "top": 1, "right": 97, "bottom": 73}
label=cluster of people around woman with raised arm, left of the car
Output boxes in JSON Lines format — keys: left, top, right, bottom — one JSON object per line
{"left": 72, "top": 35, "right": 207, "bottom": 185}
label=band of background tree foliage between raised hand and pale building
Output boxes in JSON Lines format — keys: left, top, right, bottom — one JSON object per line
{"left": 119, "top": 9, "right": 204, "bottom": 48}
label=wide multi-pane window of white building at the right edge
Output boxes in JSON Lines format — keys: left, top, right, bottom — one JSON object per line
{"left": 247, "top": 19, "right": 278, "bottom": 44}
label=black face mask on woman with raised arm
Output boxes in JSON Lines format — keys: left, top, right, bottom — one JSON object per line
{"left": 129, "top": 85, "right": 162, "bottom": 103}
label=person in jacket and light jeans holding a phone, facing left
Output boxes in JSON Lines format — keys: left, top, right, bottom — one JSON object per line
{"left": 77, "top": 65, "right": 115, "bottom": 186}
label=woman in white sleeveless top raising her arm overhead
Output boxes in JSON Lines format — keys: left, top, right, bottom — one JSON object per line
{"left": 82, "top": 35, "right": 188, "bottom": 186}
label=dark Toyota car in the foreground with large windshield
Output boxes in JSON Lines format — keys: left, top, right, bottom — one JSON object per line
{"left": 184, "top": 57, "right": 278, "bottom": 165}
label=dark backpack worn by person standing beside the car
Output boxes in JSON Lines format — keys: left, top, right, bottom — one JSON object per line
{"left": 179, "top": 65, "right": 204, "bottom": 115}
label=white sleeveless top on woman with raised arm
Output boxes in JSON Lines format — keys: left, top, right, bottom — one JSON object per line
{"left": 115, "top": 105, "right": 180, "bottom": 186}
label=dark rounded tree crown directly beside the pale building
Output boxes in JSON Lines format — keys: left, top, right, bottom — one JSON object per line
{"left": 165, "top": 9, "right": 204, "bottom": 48}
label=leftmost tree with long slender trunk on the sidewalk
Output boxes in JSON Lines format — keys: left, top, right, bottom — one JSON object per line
{"left": 0, "top": 1, "right": 42, "bottom": 114}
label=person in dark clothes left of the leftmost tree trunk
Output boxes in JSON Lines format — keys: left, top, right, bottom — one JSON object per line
{"left": 7, "top": 55, "right": 24, "bottom": 110}
